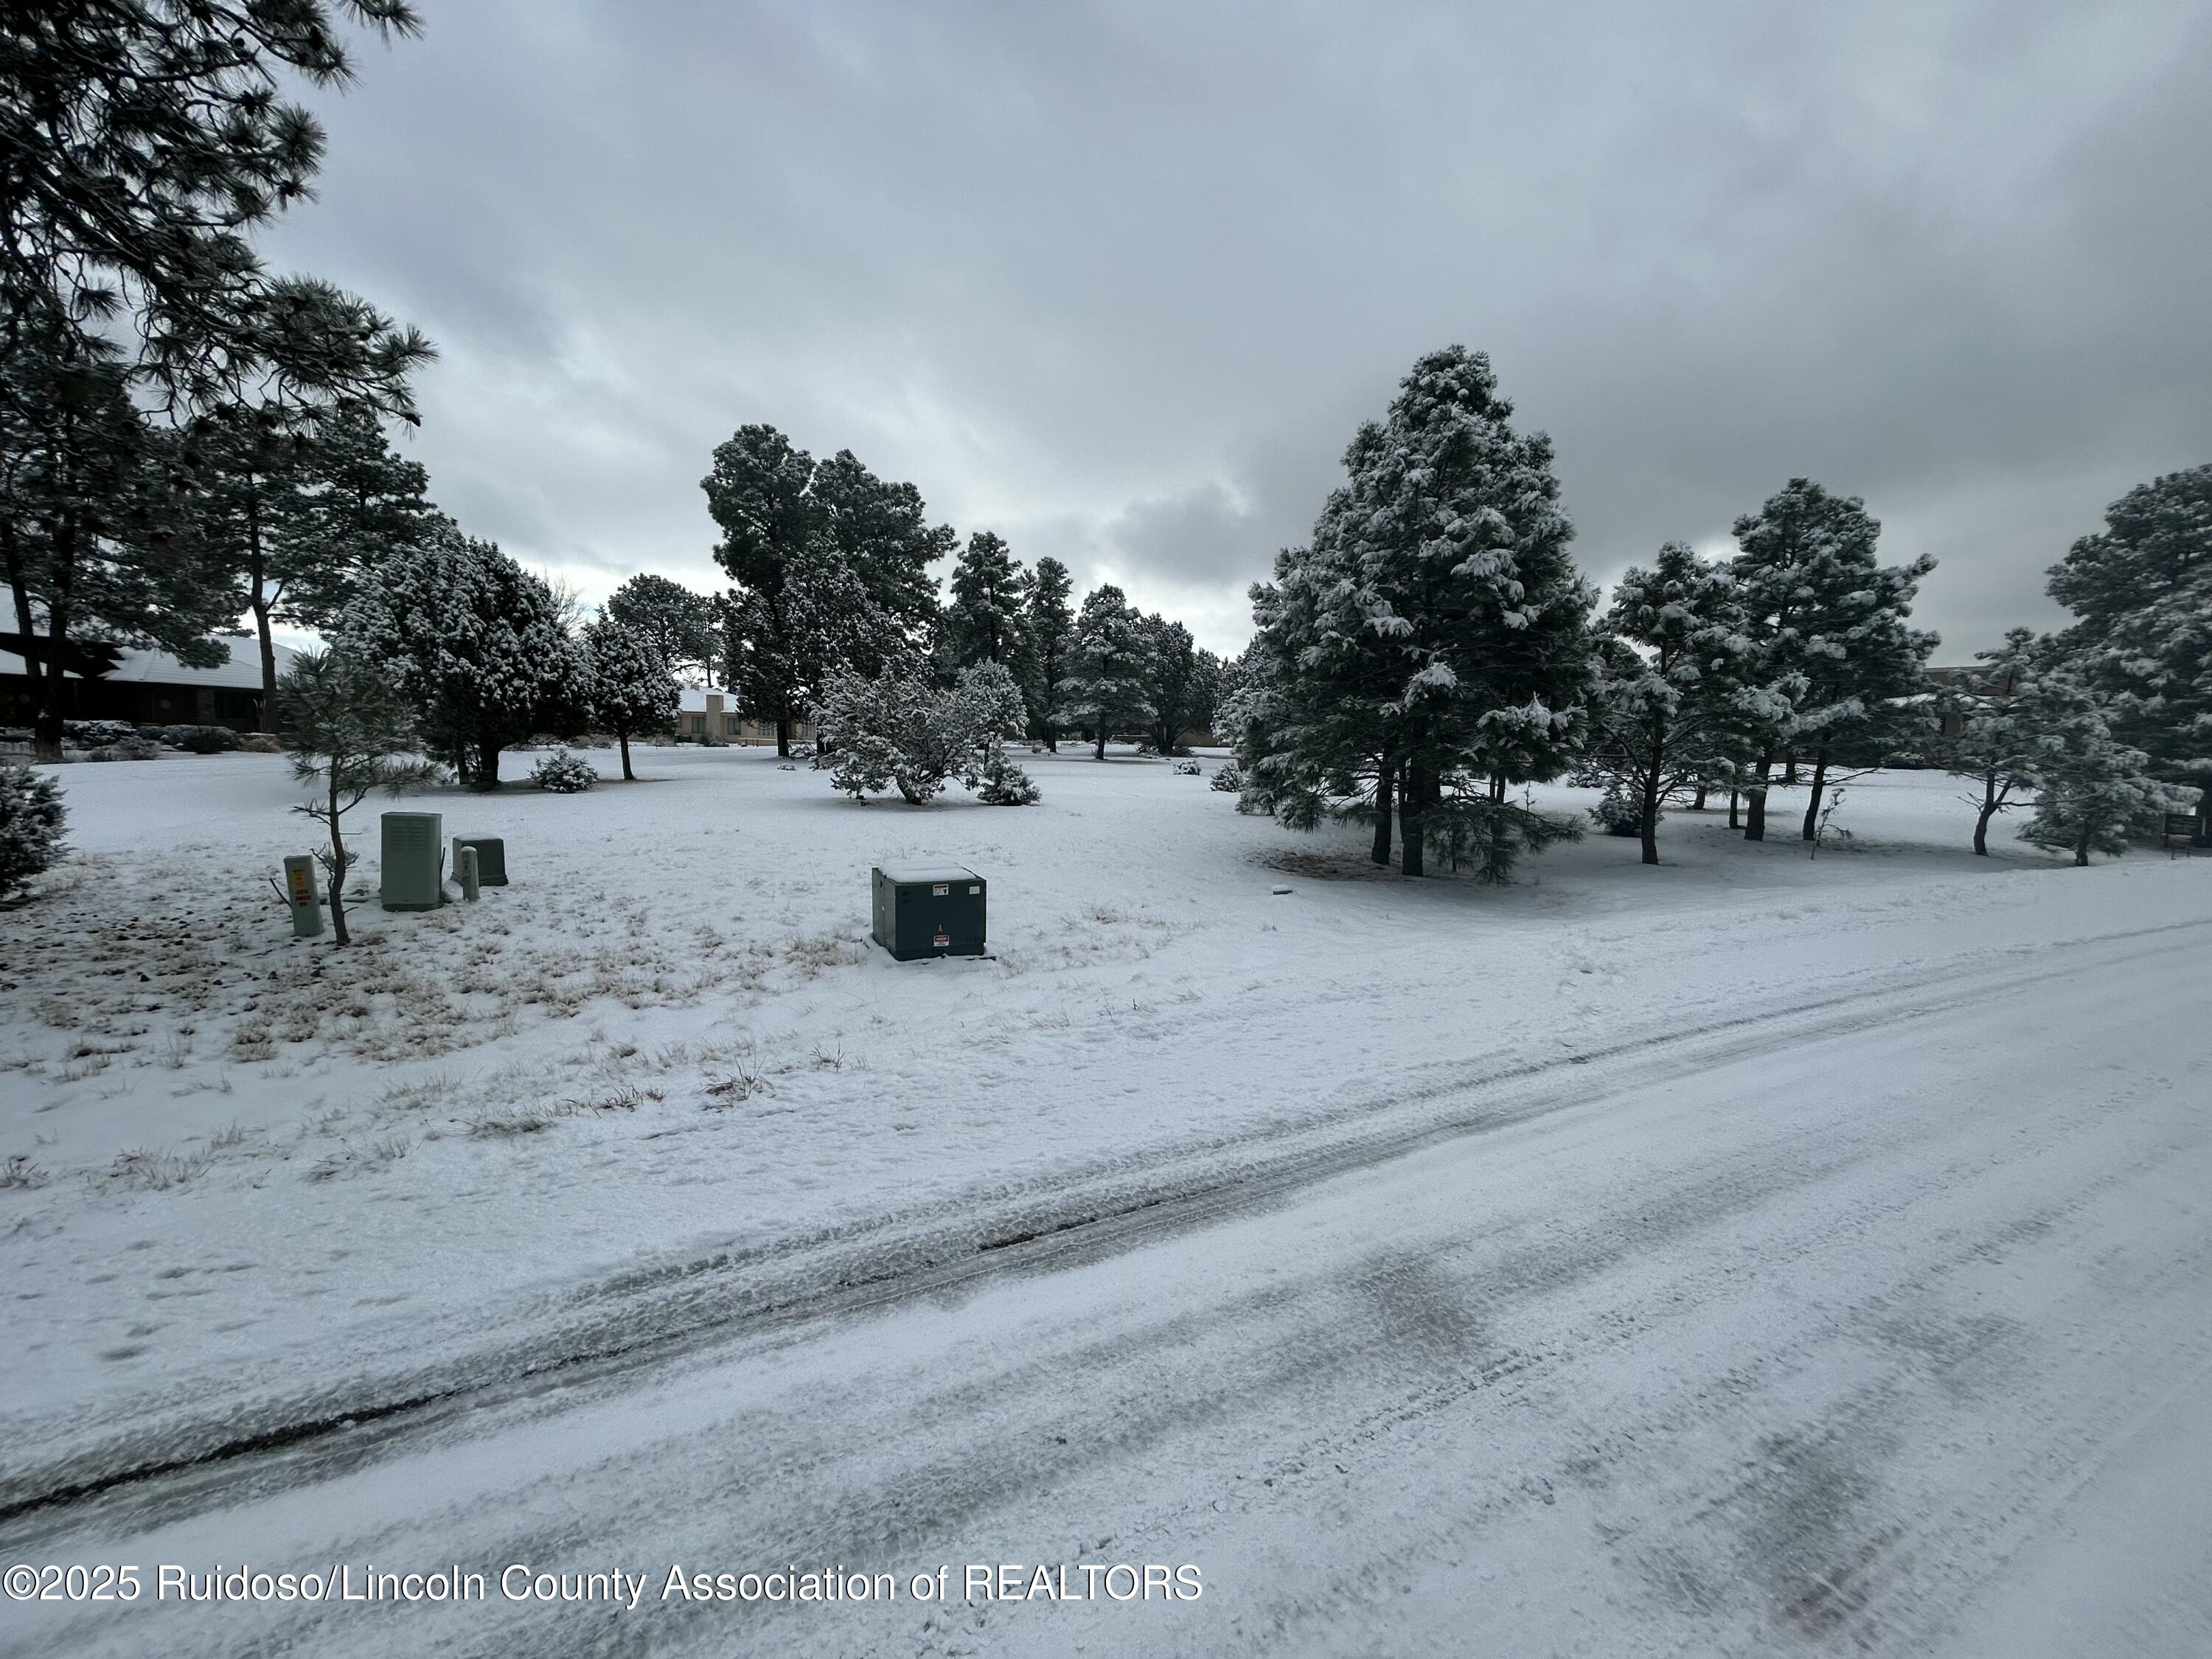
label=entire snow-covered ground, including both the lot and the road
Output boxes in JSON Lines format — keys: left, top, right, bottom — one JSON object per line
{"left": 0, "top": 750, "right": 2212, "bottom": 1652}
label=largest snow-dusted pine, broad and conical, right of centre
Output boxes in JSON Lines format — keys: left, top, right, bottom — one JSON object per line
{"left": 1254, "top": 345, "right": 1595, "bottom": 880}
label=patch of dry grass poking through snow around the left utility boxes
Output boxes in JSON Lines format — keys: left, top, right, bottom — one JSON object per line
{"left": 0, "top": 858, "right": 867, "bottom": 1082}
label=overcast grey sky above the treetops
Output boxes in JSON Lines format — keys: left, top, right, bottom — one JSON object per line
{"left": 265, "top": 0, "right": 2212, "bottom": 661}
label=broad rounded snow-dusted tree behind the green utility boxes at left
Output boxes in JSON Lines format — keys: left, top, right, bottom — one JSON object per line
{"left": 336, "top": 524, "right": 593, "bottom": 790}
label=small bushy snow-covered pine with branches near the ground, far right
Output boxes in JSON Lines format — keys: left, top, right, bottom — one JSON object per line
{"left": 2020, "top": 668, "right": 2190, "bottom": 865}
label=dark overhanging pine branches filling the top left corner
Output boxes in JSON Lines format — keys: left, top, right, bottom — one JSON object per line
{"left": 0, "top": 0, "right": 429, "bottom": 429}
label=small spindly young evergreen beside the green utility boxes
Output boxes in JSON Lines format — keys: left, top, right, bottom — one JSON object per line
{"left": 276, "top": 650, "right": 440, "bottom": 945}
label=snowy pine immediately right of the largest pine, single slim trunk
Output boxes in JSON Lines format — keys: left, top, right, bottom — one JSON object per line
{"left": 1590, "top": 542, "right": 1752, "bottom": 865}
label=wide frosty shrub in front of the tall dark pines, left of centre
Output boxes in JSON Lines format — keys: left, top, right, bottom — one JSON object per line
{"left": 814, "top": 659, "right": 1024, "bottom": 805}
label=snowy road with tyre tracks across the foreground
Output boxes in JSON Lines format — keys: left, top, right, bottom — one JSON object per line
{"left": 0, "top": 927, "right": 2212, "bottom": 1655}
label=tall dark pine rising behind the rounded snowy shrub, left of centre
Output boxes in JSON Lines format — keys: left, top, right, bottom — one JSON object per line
{"left": 701, "top": 425, "right": 956, "bottom": 754}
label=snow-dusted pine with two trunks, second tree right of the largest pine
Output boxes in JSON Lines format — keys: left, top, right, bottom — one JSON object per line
{"left": 1730, "top": 478, "right": 1938, "bottom": 841}
